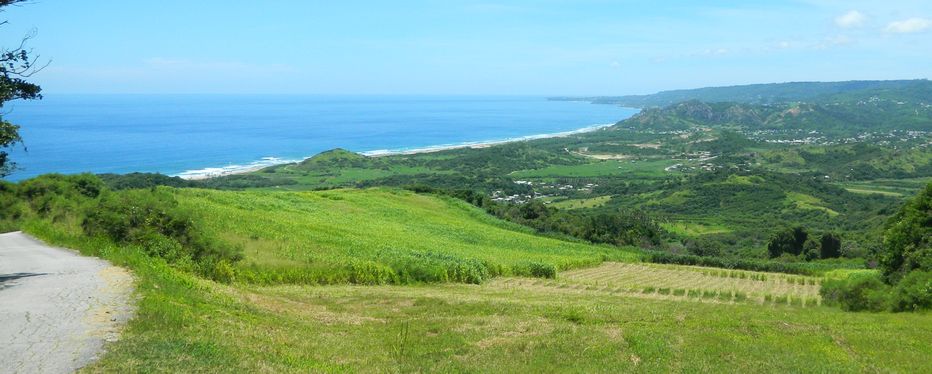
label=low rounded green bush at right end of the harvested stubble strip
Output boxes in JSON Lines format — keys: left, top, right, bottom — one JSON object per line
{"left": 819, "top": 274, "right": 890, "bottom": 312}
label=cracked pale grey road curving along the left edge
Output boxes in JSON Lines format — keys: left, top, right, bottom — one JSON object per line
{"left": 0, "top": 232, "right": 133, "bottom": 373}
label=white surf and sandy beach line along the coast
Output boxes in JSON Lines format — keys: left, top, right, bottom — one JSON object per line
{"left": 172, "top": 123, "right": 615, "bottom": 181}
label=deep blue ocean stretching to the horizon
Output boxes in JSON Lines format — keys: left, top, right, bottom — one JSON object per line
{"left": 3, "top": 94, "right": 637, "bottom": 181}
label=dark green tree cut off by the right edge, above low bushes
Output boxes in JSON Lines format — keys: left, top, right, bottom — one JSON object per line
{"left": 878, "top": 183, "right": 932, "bottom": 283}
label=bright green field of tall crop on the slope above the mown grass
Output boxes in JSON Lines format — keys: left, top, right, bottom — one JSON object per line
{"left": 176, "top": 189, "right": 636, "bottom": 284}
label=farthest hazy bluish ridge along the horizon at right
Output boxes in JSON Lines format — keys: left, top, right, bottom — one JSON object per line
{"left": 552, "top": 79, "right": 932, "bottom": 108}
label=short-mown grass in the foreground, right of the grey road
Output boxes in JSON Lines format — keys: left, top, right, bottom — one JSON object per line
{"left": 90, "top": 268, "right": 932, "bottom": 373}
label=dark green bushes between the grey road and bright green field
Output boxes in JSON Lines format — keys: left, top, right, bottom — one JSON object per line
{"left": 0, "top": 174, "right": 242, "bottom": 280}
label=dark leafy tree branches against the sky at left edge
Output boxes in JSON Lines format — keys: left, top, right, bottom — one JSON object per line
{"left": 0, "top": 0, "right": 44, "bottom": 177}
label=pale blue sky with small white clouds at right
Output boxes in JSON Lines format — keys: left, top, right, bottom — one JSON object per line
{"left": 0, "top": 0, "right": 932, "bottom": 95}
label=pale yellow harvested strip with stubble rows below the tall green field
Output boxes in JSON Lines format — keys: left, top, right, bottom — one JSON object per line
{"left": 557, "top": 263, "right": 821, "bottom": 306}
